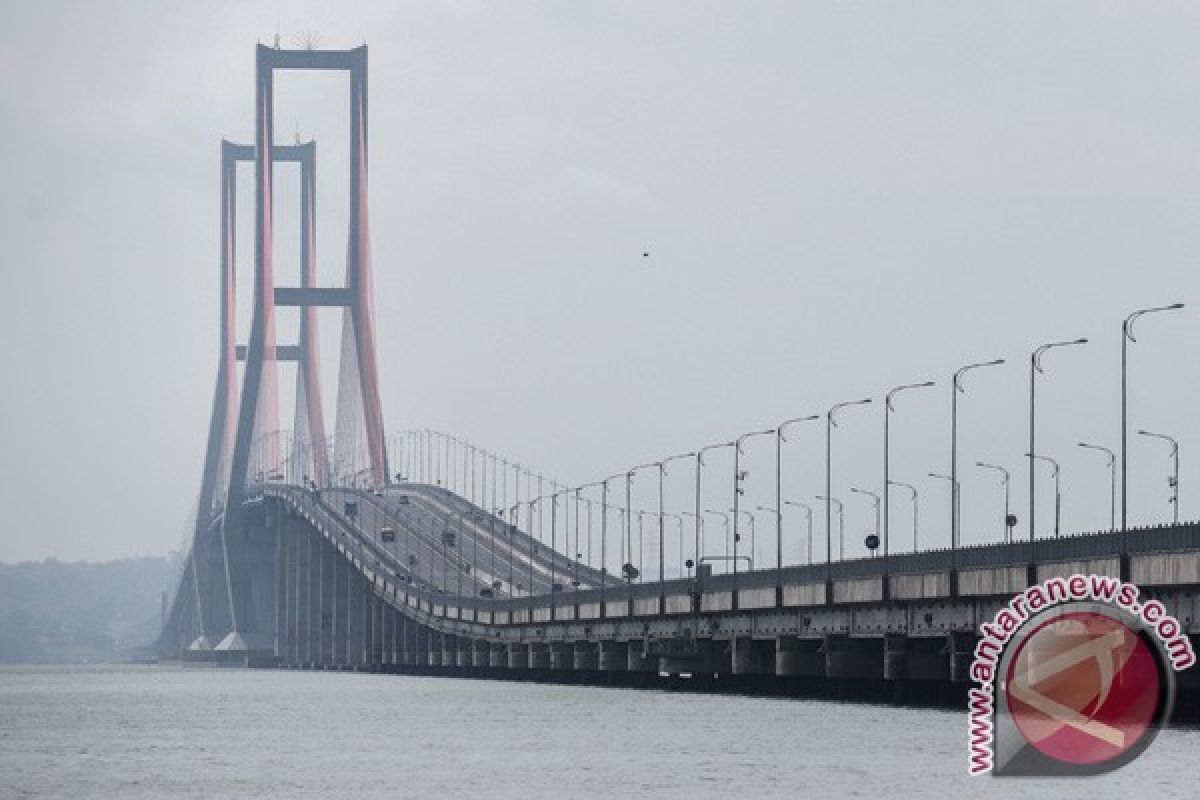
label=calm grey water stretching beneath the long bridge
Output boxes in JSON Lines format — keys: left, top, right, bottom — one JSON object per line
{"left": 0, "top": 667, "right": 1200, "bottom": 800}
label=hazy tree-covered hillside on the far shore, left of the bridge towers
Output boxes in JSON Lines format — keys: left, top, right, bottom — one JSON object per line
{"left": 0, "top": 558, "right": 175, "bottom": 663}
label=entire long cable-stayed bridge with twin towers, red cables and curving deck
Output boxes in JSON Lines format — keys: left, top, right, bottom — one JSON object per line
{"left": 158, "top": 46, "right": 1200, "bottom": 697}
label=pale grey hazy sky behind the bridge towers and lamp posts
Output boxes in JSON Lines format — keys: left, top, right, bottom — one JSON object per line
{"left": 0, "top": 0, "right": 1200, "bottom": 561}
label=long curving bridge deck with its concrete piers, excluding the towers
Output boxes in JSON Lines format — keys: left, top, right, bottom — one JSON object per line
{"left": 258, "top": 485, "right": 1200, "bottom": 691}
